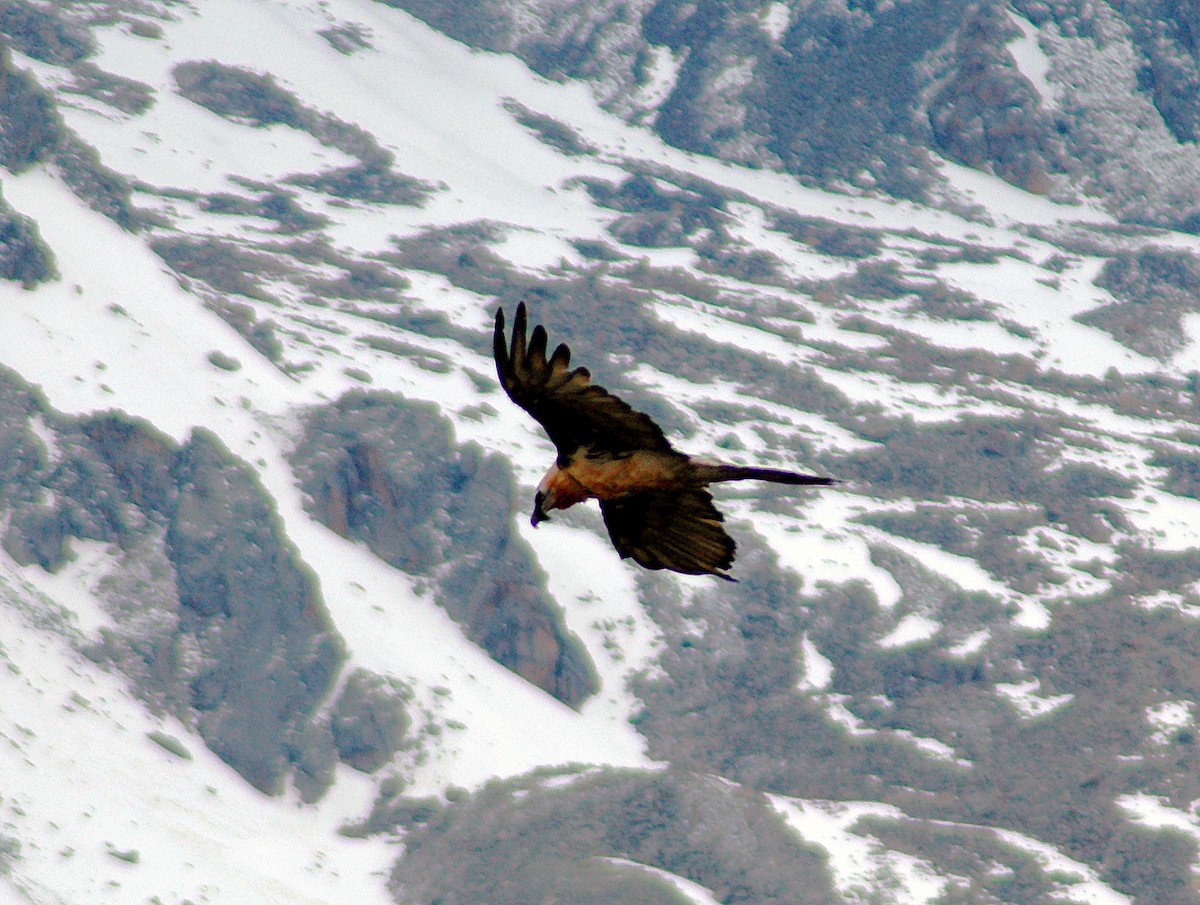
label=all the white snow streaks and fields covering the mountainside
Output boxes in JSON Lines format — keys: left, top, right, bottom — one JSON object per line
{"left": 0, "top": 0, "right": 1185, "bottom": 905}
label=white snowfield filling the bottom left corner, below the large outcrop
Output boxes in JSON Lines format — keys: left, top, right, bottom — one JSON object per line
{"left": 0, "top": 558, "right": 395, "bottom": 905}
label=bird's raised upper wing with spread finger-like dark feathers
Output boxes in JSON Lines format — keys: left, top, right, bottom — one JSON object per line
{"left": 493, "top": 302, "right": 671, "bottom": 462}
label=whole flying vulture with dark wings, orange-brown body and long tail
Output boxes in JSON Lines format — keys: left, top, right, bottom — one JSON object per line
{"left": 493, "top": 302, "right": 836, "bottom": 581}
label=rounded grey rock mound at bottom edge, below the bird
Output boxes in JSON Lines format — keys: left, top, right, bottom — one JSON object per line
{"left": 390, "top": 768, "right": 840, "bottom": 905}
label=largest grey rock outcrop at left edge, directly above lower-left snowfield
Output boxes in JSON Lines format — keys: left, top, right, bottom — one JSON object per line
{"left": 0, "top": 374, "right": 362, "bottom": 793}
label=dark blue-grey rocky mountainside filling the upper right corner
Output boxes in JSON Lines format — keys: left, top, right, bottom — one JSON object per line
{"left": 384, "top": 0, "right": 1200, "bottom": 224}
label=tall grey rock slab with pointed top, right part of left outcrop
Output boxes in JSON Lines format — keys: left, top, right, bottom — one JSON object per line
{"left": 167, "top": 431, "right": 342, "bottom": 791}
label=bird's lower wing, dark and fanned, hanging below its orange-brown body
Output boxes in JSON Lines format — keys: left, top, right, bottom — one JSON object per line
{"left": 600, "top": 489, "right": 737, "bottom": 581}
